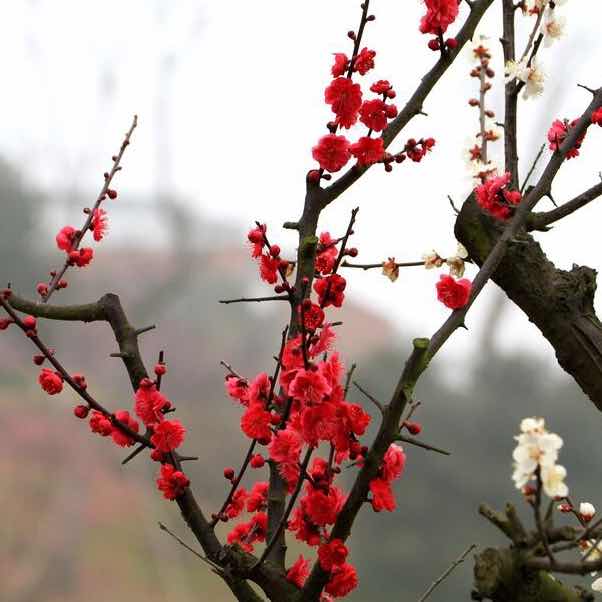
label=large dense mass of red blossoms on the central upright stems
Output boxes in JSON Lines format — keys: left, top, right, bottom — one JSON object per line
{"left": 216, "top": 226, "right": 406, "bottom": 599}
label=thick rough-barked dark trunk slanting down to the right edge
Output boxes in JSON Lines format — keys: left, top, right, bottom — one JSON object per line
{"left": 455, "top": 196, "right": 602, "bottom": 410}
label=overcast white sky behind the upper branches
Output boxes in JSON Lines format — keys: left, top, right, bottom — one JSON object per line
{"left": 0, "top": 0, "right": 602, "bottom": 376}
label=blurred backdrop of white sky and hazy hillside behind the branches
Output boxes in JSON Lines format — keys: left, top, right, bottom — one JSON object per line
{"left": 0, "top": 0, "right": 602, "bottom": 602}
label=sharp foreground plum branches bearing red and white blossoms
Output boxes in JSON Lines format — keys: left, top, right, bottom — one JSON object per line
{"left": 0, "top": 0, "right": 602, "bottom": 602}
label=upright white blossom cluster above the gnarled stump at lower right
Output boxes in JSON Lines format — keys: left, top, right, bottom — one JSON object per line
{"left": 512, "top": 418, "right": 568, "bottom": 498}
